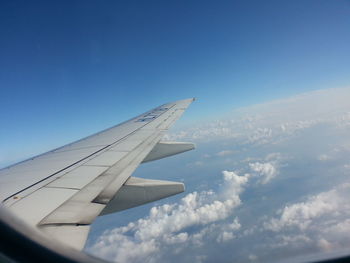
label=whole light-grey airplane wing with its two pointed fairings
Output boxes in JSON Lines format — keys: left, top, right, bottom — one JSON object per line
{"left": 0, "top": 99, "right": 194, "bottom": 262}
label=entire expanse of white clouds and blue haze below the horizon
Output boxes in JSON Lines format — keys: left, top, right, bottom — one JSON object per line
{"left": 87, "top": 89, "right": 350, "bottom": 263}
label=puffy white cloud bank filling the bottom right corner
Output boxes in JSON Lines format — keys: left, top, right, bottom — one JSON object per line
{"left": 238, "top": 183, "right": 350, "bottom": 262}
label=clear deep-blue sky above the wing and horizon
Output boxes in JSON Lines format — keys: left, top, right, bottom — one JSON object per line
{"left": 0, "top": 0, "right": 350, "bottom": 166}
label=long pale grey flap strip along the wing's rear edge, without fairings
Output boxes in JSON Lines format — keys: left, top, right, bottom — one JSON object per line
{"left": 40, "top": 132, "right": 162, "bottom": 225}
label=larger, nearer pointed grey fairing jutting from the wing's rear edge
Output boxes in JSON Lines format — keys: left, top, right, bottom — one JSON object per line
{"left": 101, "top": 177, "right": 185, "bottom": 215}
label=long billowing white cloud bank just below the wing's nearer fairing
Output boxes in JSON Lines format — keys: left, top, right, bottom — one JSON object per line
{"left": 88, "top": 171, "right": 250, "bottom": 262}
